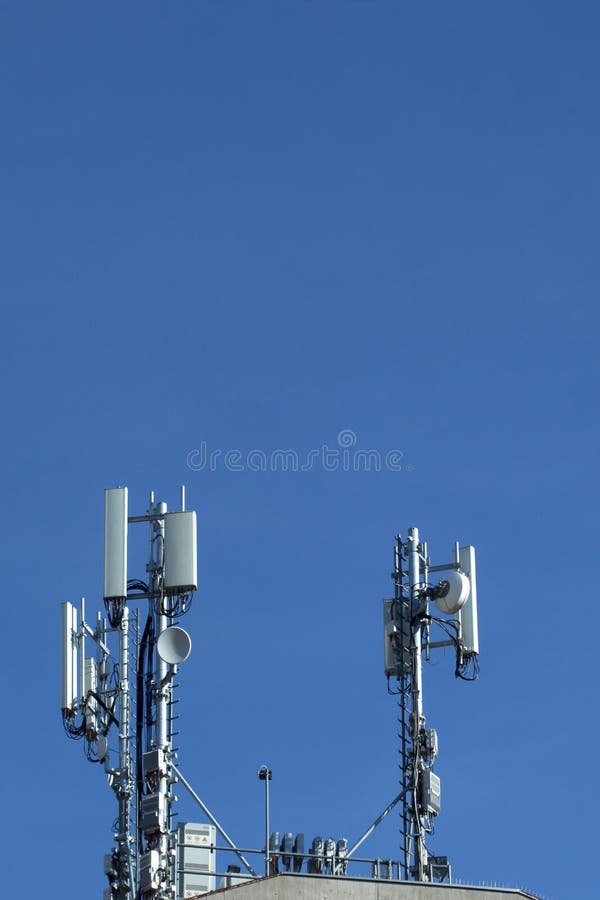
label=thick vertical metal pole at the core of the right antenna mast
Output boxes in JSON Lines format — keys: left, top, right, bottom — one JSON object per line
{"left": 407, "top": 528, "right": 427, "bottom": 881}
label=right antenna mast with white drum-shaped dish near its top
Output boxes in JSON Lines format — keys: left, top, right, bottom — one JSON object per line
{"left": 383, "top": 528, "right": 479, "bottom": 881}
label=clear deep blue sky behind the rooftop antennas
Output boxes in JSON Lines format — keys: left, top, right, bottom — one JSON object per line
{"left": 0, "top": 0, "right": 600, "bottom": 900}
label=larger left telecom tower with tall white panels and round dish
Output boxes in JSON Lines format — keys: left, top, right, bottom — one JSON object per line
{"left": 61, "top": 487, "right": 197, "bottom": 900}
